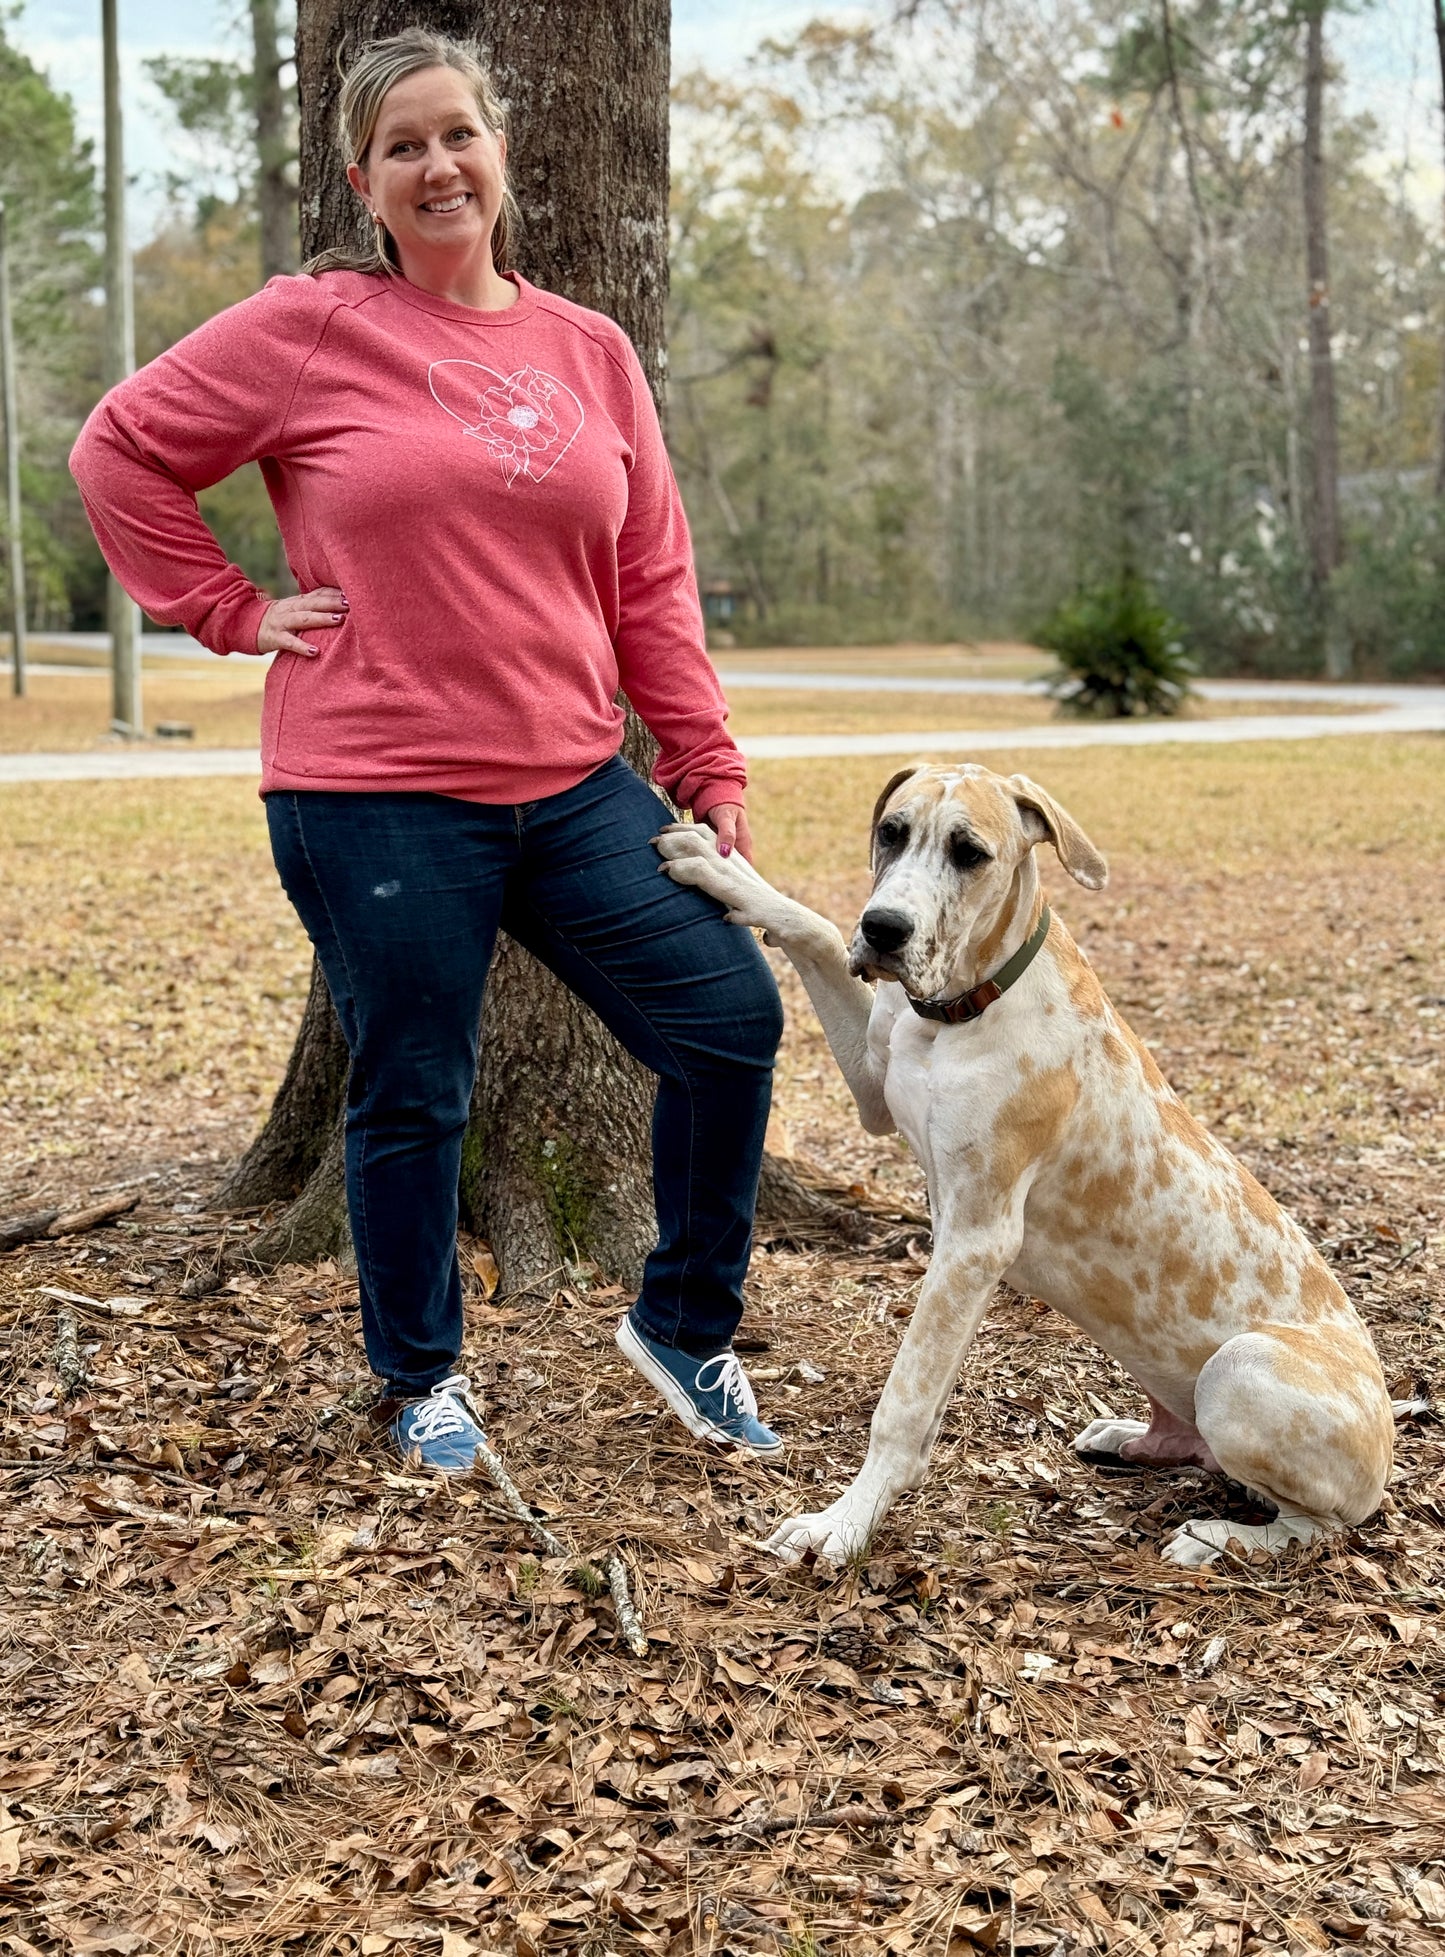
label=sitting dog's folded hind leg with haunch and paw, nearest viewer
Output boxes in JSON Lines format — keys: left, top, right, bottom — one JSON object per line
{"left": 1163, "top": 1325, "right": 1394, "bottom": 1568}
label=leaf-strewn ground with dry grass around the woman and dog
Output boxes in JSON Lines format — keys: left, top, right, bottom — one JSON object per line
{"left": 0, "top": 742, "right": 1445, "bottom": 1957}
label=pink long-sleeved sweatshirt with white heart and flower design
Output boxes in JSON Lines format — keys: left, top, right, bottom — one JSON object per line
{"left": 70, "top": 272, "right": 746, "bottom": 816}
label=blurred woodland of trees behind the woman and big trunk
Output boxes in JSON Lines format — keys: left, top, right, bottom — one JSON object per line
{"left": 0, "top": 0, "right": 1445, "bottom": 677}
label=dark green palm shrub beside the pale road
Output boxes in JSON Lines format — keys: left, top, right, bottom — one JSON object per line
{"left": 1034, "top": 571, "right": 1196, "bottom": 720}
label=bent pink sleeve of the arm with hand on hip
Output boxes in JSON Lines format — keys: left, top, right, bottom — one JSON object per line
{"left": 70, "top": 278, "right": 335, "bottom": 654}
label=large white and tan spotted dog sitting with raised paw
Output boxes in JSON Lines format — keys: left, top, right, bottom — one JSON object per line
{"left": 658, "top": 763, "right": 1392, "bottom": 1566}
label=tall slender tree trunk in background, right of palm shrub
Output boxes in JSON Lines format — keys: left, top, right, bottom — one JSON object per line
{"left": 1304, "top": 0, "right": 1351, "bottom": 679}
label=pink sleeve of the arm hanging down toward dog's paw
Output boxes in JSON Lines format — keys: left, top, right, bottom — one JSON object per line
{"left": 617, "top": 346, "right": 748, "bottom": 818}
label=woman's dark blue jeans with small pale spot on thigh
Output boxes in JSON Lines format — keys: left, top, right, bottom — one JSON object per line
{"left": 266, "top": 757, "right": 781, "bottom": 1397}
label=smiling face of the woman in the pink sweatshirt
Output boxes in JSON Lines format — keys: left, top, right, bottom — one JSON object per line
{"left": 347, "top": 68, "right": 507, "bottom": 276}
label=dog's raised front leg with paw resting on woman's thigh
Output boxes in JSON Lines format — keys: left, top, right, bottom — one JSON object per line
{"left": 656, "top": 822, "right": 893, "bottom": 1135}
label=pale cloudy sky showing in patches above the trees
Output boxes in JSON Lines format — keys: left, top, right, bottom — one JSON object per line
{"left": 8, "top": 0, "right": 1445, "bottom": 243}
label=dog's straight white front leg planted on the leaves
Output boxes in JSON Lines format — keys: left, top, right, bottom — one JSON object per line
{"left": 768, "top": 1223, "right": 1022, "bottom": 1564}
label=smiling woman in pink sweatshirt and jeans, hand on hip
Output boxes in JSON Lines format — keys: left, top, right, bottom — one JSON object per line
{"left": 70, "top": 29, "right": 781, "bottom": 1472}
